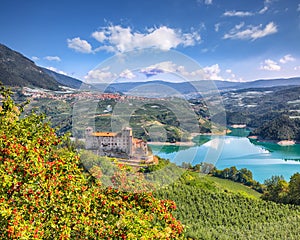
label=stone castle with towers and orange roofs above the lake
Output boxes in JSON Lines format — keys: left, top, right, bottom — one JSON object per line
{"left": 85, "top": 127, "right": 153, "bottom": 162}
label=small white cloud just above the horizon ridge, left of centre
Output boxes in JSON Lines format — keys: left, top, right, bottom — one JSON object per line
{"left": 84, "top": 67, "right": 117, "bottom": 83}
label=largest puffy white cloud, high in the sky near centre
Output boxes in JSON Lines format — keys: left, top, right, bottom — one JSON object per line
{"left": 92, "top": 25, "right": 201, "bottom": 52}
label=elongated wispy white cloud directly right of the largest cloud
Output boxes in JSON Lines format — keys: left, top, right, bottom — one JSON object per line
{"left": 223, "top": 22, "right": 278, "bottom": 40}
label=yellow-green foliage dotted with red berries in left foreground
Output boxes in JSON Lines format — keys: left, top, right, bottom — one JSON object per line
{"left": 0, "top": 87, "right": 183, "bottom": 239}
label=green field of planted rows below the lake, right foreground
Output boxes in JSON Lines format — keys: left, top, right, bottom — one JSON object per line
{"left": 156, "top": 172, "right": 300, "bottom": 240}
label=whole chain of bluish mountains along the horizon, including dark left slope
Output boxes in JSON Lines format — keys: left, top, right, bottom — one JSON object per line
{"left": 0, "top": 43, "right": 300, "bottom": 93}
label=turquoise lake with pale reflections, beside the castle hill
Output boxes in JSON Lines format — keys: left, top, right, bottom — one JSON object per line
{"left": 150, "top": 129, "right": 300, "bottom": 183}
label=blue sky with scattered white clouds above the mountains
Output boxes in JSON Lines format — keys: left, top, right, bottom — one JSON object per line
{"left": 0, "top": 0, "right": 300, "bottom": 82}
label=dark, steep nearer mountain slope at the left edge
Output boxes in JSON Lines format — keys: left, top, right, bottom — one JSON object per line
{"left": 0, "top": 44, "right": 61, "bottom": 90}
